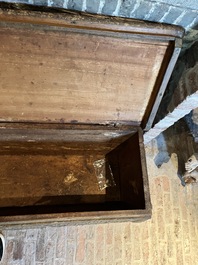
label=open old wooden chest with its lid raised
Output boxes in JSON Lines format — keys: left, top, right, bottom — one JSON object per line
{"left": 0, "top": 3, "right": 183, "bottom": 223}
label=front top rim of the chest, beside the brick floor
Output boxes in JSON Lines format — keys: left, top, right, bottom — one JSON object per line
{"left": 0, "top": 209, "right": 151, "bottom": 226}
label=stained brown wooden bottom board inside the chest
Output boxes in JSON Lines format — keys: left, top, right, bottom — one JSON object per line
{"left": 0, "top": 153, "right": 108, "bottom": 207}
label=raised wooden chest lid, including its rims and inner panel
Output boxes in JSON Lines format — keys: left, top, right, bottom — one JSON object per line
{"left": 0, "top": 3, "right": 183, "bottom": 129}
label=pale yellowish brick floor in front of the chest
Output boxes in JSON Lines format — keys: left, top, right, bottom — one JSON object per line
{"left": 2, "top": 139, "right": 198, "bottom": 265}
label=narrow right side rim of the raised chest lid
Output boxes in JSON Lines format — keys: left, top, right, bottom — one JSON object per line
{"left": 141, "top": 38, "right": 182, "bottom": 131}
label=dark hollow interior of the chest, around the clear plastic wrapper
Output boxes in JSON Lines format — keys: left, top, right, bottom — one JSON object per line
{"left": 0, "top": 123, "right": 145, "bottom": 215}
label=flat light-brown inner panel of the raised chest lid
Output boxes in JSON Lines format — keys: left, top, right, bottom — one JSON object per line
{"left": 0, "top": 23, "right": 168, "bottom": 123}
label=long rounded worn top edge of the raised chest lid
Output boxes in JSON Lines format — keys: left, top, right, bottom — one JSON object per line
{"left": 0, "top": 3, "right": 184, "bottom": 38}
